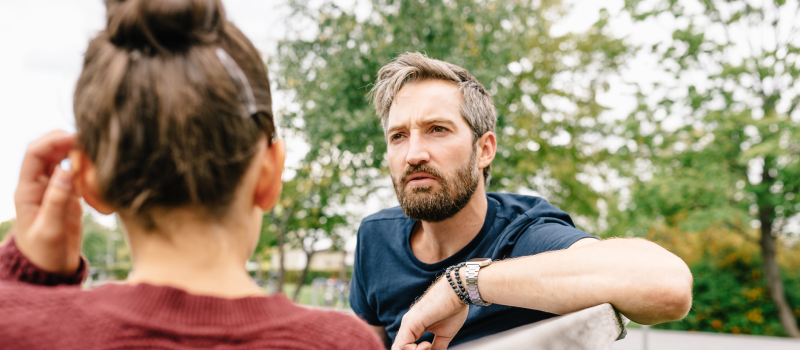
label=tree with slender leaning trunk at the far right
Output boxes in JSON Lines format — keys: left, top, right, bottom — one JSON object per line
{"left": 621, "top": 0, "right": 800, "bottom": 337}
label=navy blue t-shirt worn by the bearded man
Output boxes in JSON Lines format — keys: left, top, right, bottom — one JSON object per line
{"left": 350, "top": 193, "right": 593, "bottom": 345}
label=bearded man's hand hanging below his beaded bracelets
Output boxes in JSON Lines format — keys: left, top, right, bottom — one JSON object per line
{"left": 392, "top": 277, "right": 469, "bottom": 350}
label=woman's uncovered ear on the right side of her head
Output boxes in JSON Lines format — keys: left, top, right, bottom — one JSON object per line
{"left": 254, "top": 140, "right": 286, "bottom": 211}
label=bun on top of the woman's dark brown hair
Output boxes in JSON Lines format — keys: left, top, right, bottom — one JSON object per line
{"left": 106, "top": 0, "right": 224, "bottom": 53}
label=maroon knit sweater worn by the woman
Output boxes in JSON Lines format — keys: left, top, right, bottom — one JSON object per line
{"left": 0, "top": 239, "right": 384, "bottom": 350}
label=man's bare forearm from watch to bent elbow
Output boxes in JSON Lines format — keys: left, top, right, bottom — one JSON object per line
{"left": 478, "top": 239, "right": 692, "bottom": 324}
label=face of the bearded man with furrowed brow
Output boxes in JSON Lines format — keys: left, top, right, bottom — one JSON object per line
{"left": 386, "top": 80, "right": 480, "bottom": 222}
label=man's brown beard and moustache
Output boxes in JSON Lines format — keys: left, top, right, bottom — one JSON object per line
{"left": 392, "top": 149, "right": 480, "bottom": 222}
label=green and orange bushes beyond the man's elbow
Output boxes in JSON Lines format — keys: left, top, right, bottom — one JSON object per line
{"left": 646, "top": 227, "right": 800, "bottom": 336}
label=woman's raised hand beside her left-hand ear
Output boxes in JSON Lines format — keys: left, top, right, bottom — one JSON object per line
{"left": 14, "top": 130, "right": 82, "bottom": 274}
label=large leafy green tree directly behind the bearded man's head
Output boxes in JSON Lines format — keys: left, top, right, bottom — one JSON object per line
{"left": 273, "top": 0, "right": 629, "bottom": 232}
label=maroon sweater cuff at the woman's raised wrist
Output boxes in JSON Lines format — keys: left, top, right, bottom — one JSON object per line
{"left": 0, "top": 236, "right": 87, "bottom": 286}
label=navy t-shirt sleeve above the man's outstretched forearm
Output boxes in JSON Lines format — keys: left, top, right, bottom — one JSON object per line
{"left": 508, "top": 218, "right": 596, "bottom": 258}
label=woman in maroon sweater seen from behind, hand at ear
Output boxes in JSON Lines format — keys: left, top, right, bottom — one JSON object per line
{"left": 0, "top": 0, "right": 383, "bottom": 349}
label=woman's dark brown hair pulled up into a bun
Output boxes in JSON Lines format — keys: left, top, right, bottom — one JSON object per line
{"left": 74, "top": 0, "right": 275, "bottom": 228}
